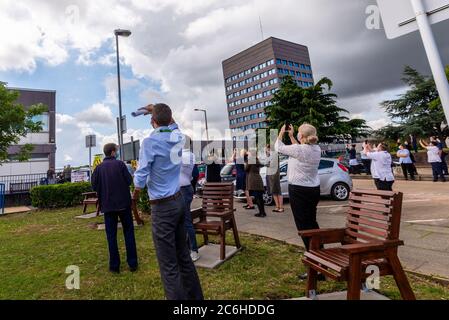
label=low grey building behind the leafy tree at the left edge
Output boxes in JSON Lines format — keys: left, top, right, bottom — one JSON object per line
{"left": 0, "top": 88, "right": 56, "bottom": 177}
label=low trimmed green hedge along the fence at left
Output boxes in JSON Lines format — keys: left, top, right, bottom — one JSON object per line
{"left": 31, "top": 182, "right": 92, "bottom": 209}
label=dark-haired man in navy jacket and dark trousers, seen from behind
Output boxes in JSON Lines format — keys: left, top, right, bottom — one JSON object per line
{"left": 92, "top": 143, "right": 138, "bottom": 273}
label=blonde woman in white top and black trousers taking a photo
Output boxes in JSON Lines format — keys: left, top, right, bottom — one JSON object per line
{"left": 275, "top": 124, "right": 321, "bottom": 250}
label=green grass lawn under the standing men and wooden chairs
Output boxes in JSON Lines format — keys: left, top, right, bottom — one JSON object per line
{"left": 0, "top": 208, "right": 449, "bottom": 300}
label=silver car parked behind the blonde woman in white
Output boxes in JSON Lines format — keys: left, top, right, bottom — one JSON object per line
{"left": 222, "top": 158, "right": 353, "bottom": 205}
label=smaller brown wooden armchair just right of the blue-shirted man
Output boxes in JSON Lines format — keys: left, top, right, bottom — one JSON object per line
{"left": 192, "top": 183, "right": 242, "bottom": 261}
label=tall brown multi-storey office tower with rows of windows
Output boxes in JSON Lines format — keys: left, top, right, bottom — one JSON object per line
{"left": 223, "top": 37, "right": 314, "bottom": 137}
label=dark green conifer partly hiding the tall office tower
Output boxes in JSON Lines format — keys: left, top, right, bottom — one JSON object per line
{"left": 265, "top": 77, "right": 370, "bottom": 141}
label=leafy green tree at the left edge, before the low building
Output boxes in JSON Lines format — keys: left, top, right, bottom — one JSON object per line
{"left": 0, "top": 82, "right": 47, "bottom": 165}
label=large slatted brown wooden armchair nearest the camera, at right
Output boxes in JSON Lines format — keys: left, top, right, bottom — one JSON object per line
{"left": 299, "top": 190, "right": 416, "bottom": 300}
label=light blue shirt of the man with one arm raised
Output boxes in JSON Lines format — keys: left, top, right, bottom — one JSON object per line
{"left": 134, "top": 123, "right": 184, "bottom": 200}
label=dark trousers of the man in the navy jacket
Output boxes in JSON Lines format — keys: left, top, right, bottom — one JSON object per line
{"left": 104, "top": 208, "right": 138, "bottom": 271}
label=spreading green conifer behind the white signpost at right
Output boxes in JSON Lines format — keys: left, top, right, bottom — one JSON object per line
{"left": 377, "top": 66, "right": 449, "bottom": 141}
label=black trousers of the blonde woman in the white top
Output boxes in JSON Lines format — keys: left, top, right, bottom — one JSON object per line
{"left": 288, "top": 185, "right": 321, "bottom": 251}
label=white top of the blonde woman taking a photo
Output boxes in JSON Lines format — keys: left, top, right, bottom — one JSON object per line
{"left": 274, "top": 139, "right": 321, "bottom": 188}
